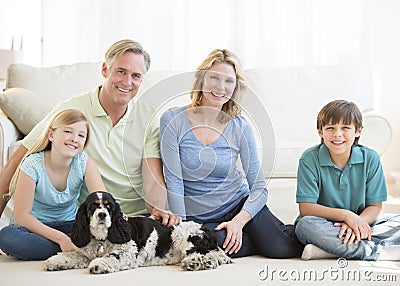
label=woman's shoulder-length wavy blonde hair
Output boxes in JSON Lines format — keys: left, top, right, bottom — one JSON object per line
{"left": 190, "top": 49, "right": 246, "bottom": 121}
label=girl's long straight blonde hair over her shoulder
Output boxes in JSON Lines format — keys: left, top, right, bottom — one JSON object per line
{"left": 5, "top": 109, "right": 89, "bottom": 199}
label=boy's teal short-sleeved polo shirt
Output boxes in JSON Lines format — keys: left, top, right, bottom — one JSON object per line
{"left": 296, "top": 144, "right": 387, "bottom": 214}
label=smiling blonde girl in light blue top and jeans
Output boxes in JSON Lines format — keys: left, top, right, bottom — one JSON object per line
{"left": 0, "top": 109, "right": 105, "bottom": 260}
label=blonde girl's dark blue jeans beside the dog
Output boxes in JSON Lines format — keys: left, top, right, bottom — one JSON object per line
{"left": 0, "top": 221, "right": 73, "bottom": 260}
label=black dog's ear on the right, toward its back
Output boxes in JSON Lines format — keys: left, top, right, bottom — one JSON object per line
{"left": 107, "top": 200, "right": 131, "bottom": 244}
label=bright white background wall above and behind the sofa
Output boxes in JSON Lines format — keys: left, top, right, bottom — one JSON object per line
{"left": 0, "top": 0, "right": 400, "bottom": 188}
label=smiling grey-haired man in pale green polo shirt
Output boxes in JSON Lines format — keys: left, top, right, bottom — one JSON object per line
{"left": 0, "top": 40, "right": 180, "bottom": 226}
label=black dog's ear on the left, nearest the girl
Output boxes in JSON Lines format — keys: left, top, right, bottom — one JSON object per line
{"left": 71, "top": 202, "right": 91, "bottom": 247}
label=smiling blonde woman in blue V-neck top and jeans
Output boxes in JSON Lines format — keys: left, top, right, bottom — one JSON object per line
{"left": 160, "top": 50, "right": 303, "bottom": 258}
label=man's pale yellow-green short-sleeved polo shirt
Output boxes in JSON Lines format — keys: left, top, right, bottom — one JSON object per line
{"left": 22, "top": 88, "right": 160, "bottom": 215}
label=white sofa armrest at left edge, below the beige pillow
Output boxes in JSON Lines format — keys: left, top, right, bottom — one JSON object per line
{"left": 0, "top": 116, "right": 21, "bottom": 170}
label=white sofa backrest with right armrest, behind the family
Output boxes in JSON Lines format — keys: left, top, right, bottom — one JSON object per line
{"left": 6, "top": 63, "right": 391, "bottom": 178}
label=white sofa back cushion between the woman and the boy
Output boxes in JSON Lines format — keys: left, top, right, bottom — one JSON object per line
{"left": 242, "top": 65, "right": 375, "bottom": 178}
